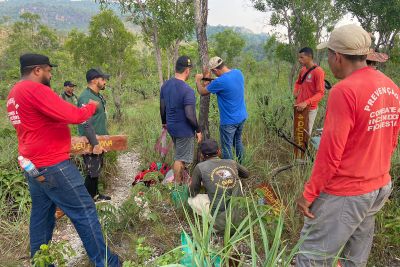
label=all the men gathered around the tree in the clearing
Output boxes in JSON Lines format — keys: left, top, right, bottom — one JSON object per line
{"left": 7, "top": 25, "right": 400, "bottom": 266}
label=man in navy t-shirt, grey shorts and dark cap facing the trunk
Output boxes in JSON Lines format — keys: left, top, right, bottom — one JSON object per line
{"left": 160, "top": 56, "right": 201, "bottom": 183}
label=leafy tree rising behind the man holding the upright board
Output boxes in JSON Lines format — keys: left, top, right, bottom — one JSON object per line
{"left": 251, "top": 0, "right": 342, "bottom": 87}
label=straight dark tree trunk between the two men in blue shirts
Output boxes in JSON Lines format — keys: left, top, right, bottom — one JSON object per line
{"left": 194, "top": 0, "right": 210, "bottom": 139}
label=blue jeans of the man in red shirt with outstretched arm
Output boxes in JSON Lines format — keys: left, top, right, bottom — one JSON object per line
{"left": 27, "top": 160, "right": 122, "bottom": 267}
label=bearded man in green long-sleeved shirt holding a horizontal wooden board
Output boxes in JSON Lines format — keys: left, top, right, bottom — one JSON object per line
{"left": 78, "top": 69, "right": 111, "bottom": 201}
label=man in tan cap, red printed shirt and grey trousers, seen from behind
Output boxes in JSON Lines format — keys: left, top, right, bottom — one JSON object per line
{"left": 296, "top": 25, "right": 400, "bottom": 266}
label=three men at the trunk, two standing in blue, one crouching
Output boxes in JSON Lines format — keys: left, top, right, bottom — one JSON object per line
{"left": 160, "top": 56, "right": 249, "bottom": 232}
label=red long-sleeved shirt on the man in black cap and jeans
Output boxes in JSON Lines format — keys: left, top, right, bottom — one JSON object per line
{"left": 7, "top": 80, "right": 96, "bottom": 168}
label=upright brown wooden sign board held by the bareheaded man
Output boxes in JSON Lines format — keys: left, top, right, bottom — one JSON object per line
{"left": 293, "top": 107, "right": 309, "bottom": 159}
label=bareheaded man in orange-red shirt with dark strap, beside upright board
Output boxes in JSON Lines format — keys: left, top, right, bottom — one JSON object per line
{"left": 293, "top": 47, "right": 325, "bottom": 135}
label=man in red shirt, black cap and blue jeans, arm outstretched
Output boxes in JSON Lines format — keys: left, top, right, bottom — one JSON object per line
{"left": 7, "top": 54, "right": 121, "bottom": 266}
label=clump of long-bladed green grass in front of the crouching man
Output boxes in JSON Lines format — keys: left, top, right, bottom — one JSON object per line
{"left": 178, "top": 192, "right": 300, "bottom": 267}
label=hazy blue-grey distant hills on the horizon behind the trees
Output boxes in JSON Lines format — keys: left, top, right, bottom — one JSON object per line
{"left": 0, "top": 0, "right": 268, "bottom": 60}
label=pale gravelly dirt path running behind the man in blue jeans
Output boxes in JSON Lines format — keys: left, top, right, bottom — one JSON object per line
{"left": 53, "top": 152, "right": 139, "bottom": 267}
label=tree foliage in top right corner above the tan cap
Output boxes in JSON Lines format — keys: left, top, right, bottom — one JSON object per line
{"left": 336, "top": 0, "right": 400, "bottom": 52}
